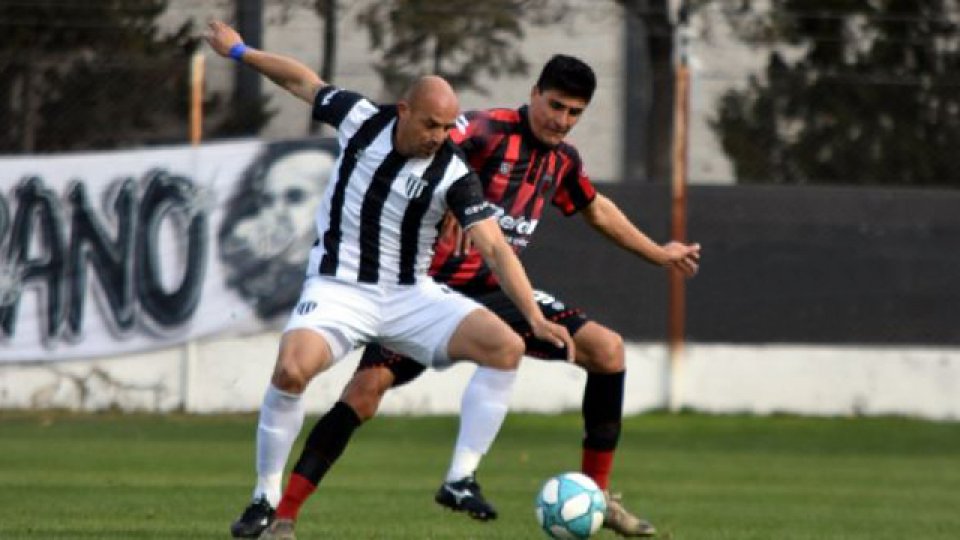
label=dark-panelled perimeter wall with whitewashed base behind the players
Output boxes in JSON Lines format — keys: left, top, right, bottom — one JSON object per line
{"left": 0, "top": 162, "right": 960, "bottom": 420}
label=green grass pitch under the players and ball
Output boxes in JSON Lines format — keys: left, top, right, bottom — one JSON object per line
{"left": 0, "top": 412, "right": 960, "bottom": 540}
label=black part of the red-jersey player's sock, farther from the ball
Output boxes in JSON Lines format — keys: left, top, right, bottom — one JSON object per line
{"left": 293, "top": 401, "right": 361, "bottom": 485}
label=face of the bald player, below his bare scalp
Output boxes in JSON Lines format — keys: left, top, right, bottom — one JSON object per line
{"left": 396, "top": 102, "right": 459, "bottom": 158}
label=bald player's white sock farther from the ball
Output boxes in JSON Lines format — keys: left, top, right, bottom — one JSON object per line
{"left": 253, "top": 384, "right": 305, "bottom": 508}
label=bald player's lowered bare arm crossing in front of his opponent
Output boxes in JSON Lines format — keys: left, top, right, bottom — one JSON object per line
{"left": 466, "top": 219, "right": 576, "bottom": 362}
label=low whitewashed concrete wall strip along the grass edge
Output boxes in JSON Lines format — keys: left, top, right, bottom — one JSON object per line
{"left": 0, "top": 333, "right": 960, "bottom": 421}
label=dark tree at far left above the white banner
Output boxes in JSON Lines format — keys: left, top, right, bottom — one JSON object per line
{"left": 0, "top": 0, "right": 269, "bottom": 153}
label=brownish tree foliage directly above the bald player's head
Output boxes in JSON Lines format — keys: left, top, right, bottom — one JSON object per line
{"left": 357, "top": 0, "right": 567, "bottom": 97}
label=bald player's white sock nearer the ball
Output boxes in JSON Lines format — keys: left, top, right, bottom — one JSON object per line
{"left": 446, "top": 367, "right": 517, "bottom": 482}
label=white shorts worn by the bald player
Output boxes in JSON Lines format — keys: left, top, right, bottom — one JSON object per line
{"left": 284, "top": 276, "right": 483, "bottom": 368}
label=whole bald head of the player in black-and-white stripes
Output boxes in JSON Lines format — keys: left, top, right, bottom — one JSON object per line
{"left": 394, "top": 75, "right": 460, "bottom": 158}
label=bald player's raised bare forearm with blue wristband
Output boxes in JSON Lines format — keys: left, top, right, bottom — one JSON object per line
{"left": 204, "top": 21, "right": 326, "bottom": 105}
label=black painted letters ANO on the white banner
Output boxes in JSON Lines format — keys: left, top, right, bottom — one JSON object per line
{"left": 0, "top": 169, "right": 209, "bottom": 340}
